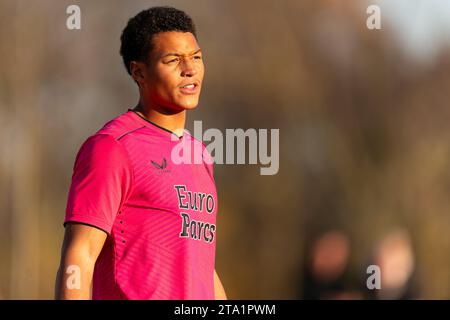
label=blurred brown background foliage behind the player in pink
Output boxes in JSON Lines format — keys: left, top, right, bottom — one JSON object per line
{"left": 0, "top": 0, "right": 450, "bottom": 299}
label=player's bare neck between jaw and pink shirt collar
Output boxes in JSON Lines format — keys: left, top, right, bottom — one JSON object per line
{"left": 133, "top": 99, "right": 186, "bottom": 137}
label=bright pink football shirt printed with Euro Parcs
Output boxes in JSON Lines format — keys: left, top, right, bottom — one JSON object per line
{"left": 64, "top": 109, "right": 218, "bottom": 300}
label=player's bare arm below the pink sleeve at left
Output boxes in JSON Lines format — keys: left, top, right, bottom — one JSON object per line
{"left": 55, "top": 223, "right": 107, "bottom": 300}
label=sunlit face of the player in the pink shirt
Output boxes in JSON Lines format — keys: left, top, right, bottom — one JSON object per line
{"left": 143, "top": 31, "right": 204, "bottom": 111}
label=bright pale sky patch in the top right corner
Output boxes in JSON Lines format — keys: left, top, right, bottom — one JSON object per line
{"left": 366, "top": 0, "right": 450, "bottom": 61}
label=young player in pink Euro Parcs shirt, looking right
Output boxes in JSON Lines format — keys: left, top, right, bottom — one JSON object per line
{"left": 55, "top": 7, "right": 226, "bottom": 299}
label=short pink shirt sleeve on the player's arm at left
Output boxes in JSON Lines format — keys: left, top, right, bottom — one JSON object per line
{"left": 64, "top": 134, "right": 132, "bottom": 234}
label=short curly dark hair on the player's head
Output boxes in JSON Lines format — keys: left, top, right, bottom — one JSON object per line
{"left": 120, "top": 6, "right": 197, "bottom": 75}
